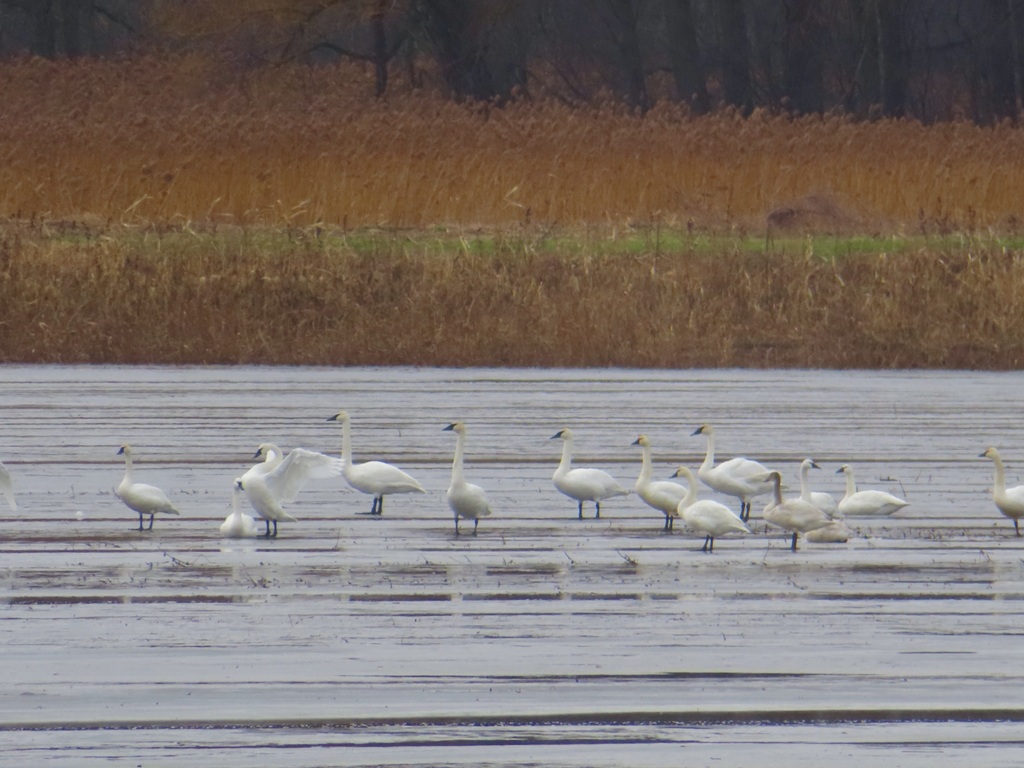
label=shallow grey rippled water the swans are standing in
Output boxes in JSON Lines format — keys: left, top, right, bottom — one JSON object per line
{"left": 0, "top": 367, "right": 1024, "bottom": 767}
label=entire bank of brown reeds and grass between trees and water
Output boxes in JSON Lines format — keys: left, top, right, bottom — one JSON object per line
{"left": 0, "top": 58, "right": 1024, "bottom": 369}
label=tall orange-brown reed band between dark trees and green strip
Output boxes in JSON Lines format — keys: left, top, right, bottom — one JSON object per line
{"left": 0, "top": 57, "right": 1024, "bottom": 230}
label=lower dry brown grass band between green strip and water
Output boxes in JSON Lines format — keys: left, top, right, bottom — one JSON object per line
{"left": 6, "top": 223, "right": 1024, "bottom": 369}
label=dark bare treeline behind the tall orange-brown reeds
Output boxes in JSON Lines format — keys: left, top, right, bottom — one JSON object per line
{"left": 0, "top": 0, "right": 1024, "bottom": 124}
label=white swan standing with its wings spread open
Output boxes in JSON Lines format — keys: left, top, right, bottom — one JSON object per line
{"left": 238, "top": 442, "right": 342, "bottom": 539}
